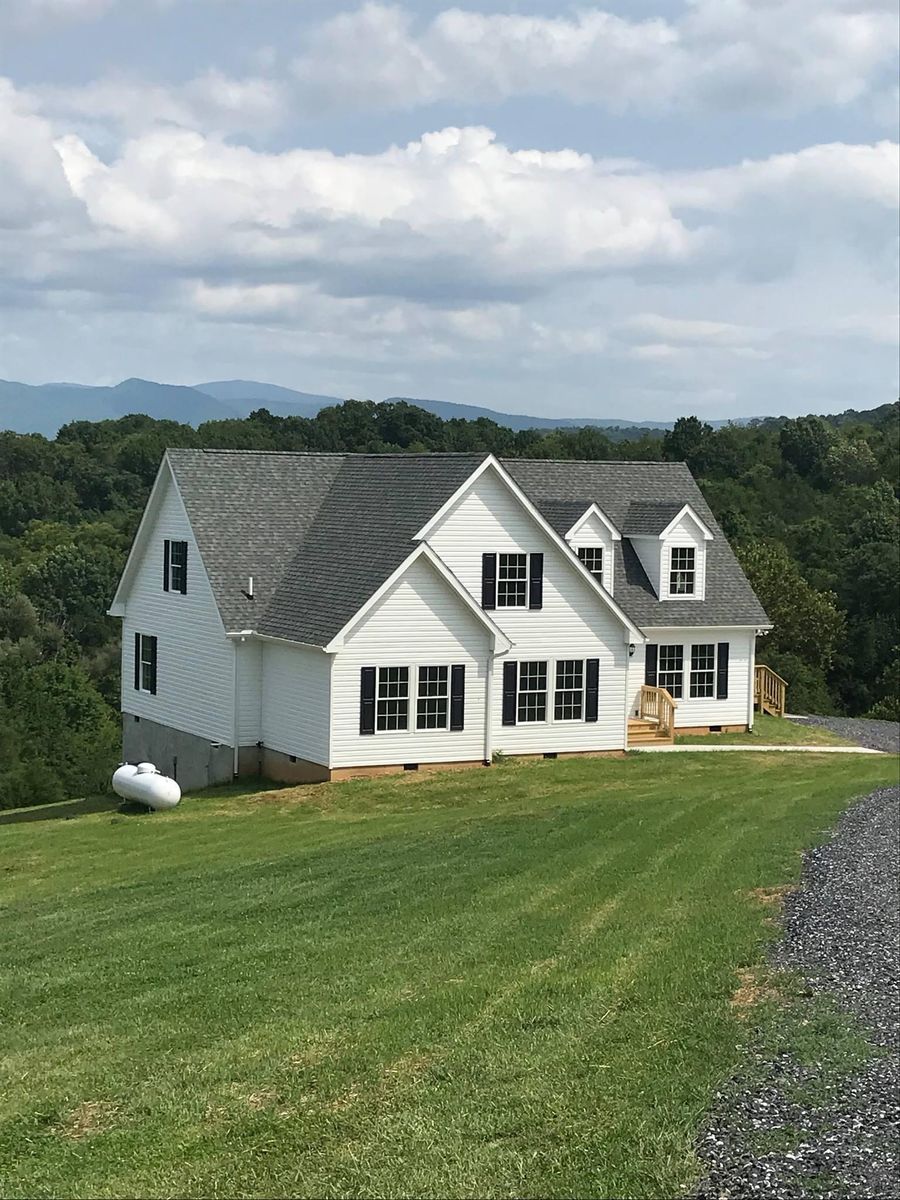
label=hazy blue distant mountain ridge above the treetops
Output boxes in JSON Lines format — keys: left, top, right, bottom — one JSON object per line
{"left": 0, "top": 379, "right": 744, "bottom": 438}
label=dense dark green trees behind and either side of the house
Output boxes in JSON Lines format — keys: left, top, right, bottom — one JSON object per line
{"left": 0, "top": 401, "right": 900, "bottom": 808}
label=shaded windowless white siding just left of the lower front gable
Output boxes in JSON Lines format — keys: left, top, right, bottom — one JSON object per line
{"left": 260, "top": 642, "right": 331, "bottom": 767}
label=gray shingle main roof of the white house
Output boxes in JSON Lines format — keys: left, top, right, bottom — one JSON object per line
{"left": 162, "top": 450, "right": 767, "bottom": 646}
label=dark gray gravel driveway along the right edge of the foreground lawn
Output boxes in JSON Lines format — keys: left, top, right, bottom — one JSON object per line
{"left": 697, "top": 787, "right": 900, "bottom": 1200}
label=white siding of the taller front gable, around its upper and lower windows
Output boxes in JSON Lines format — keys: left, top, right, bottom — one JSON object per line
{"left": 428, "top": 470, "right": 629, "bottom": 754}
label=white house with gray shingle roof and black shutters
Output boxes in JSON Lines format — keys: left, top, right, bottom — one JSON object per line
{"left": 109, "top": 450, "right": 770, "bottom": 787}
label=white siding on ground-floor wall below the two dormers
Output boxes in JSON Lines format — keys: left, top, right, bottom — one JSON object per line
{"left": 643, "top": 628, "right": 755, "bottom": 728}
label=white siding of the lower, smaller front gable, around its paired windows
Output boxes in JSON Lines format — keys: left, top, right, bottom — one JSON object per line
{"left": 330, "top": 551, "right": 489, "bottom": 767}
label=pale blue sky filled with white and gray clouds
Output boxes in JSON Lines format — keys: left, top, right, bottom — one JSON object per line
{"left": 0, "top": 0, "right": 899, "bottom": 419}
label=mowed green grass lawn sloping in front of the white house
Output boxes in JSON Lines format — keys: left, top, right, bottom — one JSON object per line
{"left": 0, "top": 755, "right": 896, "bottom": 1198}
